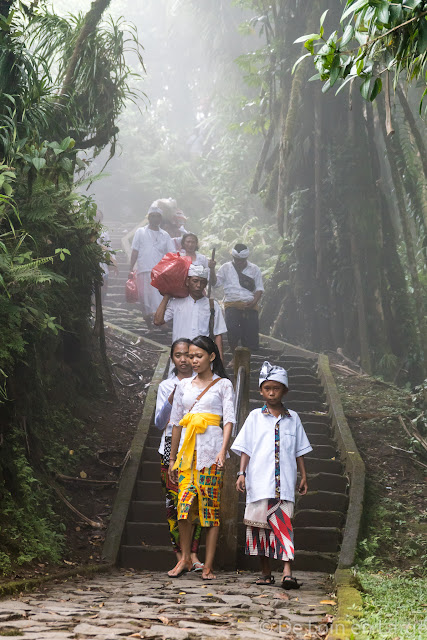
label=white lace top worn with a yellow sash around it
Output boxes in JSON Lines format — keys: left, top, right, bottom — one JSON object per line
{"left": 170, "top": 375, "right": 236, "bottom": 470}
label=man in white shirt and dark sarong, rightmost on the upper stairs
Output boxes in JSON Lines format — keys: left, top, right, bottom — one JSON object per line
{"left": 212, "top": 244, "right": 264, "bottom": 351}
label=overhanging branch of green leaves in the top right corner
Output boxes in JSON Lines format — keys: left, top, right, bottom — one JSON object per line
{"left": 295, "top": 0, "right": 427, "bottom": 101}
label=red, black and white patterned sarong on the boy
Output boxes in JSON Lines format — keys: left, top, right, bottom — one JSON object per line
{"left": 245, "top": 498, "right": 294, "bottom": 561}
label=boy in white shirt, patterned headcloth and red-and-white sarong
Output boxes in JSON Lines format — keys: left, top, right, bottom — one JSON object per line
{"left": 231, "top": 361, "right": 312, "bottom": 589}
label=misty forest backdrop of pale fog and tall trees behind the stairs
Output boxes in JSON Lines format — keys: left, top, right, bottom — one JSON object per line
{"left": 54, "top": 0, "right": 427, "bottom": 384}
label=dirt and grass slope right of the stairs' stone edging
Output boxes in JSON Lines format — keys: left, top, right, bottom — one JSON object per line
{"left": 337, "top": 376, "right": 427, "bottom": 640}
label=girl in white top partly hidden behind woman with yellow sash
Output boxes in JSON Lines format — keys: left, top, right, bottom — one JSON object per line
{"left": 154, "top": 338, "right": 203, "bottom": 571}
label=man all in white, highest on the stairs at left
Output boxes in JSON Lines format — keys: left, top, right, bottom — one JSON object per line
{"left": 130, "top": 207, "right": 175, "bottom": 327}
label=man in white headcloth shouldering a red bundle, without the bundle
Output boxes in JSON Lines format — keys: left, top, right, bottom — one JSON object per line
{"left": 154, "top": 264, "right": 227, "bottom": 359}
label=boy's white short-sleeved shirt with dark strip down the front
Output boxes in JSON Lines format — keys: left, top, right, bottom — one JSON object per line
{"left": 231, "top": 408, "right": 313, "bottom": 503}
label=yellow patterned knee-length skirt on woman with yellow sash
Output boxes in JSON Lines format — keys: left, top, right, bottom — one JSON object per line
{"left": 178, "top": 452, "right": 223, "bottom": 527}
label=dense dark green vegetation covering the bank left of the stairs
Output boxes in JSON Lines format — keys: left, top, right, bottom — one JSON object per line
{"left": 0, "top": 1, "right": 144, "bottom": 574}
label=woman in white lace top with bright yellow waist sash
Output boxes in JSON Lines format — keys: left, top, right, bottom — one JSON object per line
{"left": 168, "top": 336, "right": 235, "bottom": 580}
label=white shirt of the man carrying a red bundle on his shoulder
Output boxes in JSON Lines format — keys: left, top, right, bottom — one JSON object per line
{"left": 165, "top": 296, "right": 227, "bottom": 342}
